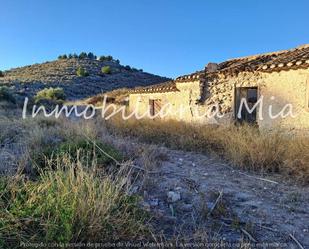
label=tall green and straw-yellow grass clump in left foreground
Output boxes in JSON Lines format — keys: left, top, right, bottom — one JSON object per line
{"left": 0, "top": 156, "right": 148, "bottom": 245}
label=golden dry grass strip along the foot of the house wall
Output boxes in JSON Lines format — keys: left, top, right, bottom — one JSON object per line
{"left": 107, "top": 118, "right": 309, "bottom": 184}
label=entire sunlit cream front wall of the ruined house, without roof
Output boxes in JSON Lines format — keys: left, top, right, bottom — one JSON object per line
{"left": 130, "top": 69, "right": 309, "bottom": 130}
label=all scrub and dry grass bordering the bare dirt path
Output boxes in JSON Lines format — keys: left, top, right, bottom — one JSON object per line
{"left": 0, "top": 103, "right": 309, "bottom": 245}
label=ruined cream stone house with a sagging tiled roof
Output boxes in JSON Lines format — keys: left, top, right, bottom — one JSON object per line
{"left": 129, "top": 45, "right": 309, "bottom": 130}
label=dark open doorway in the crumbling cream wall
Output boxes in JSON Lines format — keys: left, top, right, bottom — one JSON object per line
{"left": 234, "top": 87, "right": 258, "bottom": 124}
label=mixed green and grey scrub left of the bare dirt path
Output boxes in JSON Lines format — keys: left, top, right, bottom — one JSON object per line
{"left": 0, "top": 117, "right": 149, "bottom": 248}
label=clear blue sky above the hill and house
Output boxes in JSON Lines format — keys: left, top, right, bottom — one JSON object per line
{"left": 0, "top": 0, "right": 309, "bottom": 77}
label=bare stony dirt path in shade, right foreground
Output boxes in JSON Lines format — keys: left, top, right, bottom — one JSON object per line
{"left": 118, "top": 140, "right": 309, "bottom": 248}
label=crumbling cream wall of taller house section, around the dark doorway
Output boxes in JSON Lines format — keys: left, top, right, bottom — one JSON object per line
{"left": 200, "top": 69, "right": 309, "bottom": 130}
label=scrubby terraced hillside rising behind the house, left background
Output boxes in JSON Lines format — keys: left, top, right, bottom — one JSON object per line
{"left": 0, "top": 58, "right": 168, "bottom": 100}
